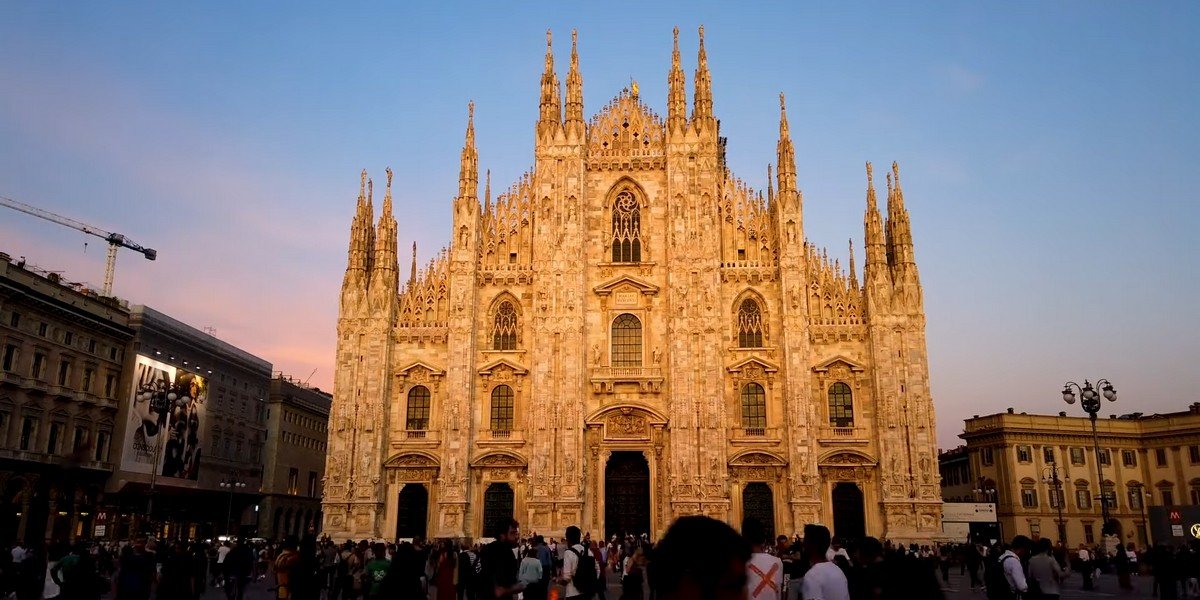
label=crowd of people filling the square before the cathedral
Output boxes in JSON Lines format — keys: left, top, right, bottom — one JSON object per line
{"left": 0, "top": 523, "right": 1200, "bottom": 600}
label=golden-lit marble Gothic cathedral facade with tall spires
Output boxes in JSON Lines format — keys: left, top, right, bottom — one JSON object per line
{"left": 323, "top": 29, "right": 941, "bottom": 540}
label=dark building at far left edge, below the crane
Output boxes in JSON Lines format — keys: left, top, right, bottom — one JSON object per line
{"left": 0, "top": 253, "right": 133, "bottom": 544}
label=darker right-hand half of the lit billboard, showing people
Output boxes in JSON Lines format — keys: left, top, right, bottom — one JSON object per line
{"left": 160, "top": 371, "right": 209, "bottom": 481}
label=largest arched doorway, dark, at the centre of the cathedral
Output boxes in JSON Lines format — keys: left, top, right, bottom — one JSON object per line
{"left": 604, "top": 451, "right": 650, "bottom": 538}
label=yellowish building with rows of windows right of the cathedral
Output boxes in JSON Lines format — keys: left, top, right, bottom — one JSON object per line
{"left": 961, "top": 403, "right": 1200, "bottom": 546}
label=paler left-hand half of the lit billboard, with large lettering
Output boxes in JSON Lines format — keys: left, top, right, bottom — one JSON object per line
{"left": 121, "top": 354, "right": 175, "bottom": 474}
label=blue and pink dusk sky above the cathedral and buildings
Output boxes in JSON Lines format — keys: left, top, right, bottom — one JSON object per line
{"left": 0, "top": 1, "right": 1200, "bottom": 448}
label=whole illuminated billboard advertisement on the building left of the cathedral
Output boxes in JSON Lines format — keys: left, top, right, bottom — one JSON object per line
{"left": 121, "top": 354, "right": 208, "bottom": 481}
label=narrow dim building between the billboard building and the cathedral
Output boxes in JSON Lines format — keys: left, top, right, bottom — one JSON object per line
{"left": 258, "top": 374, "right": 332, "bottom": 540}
